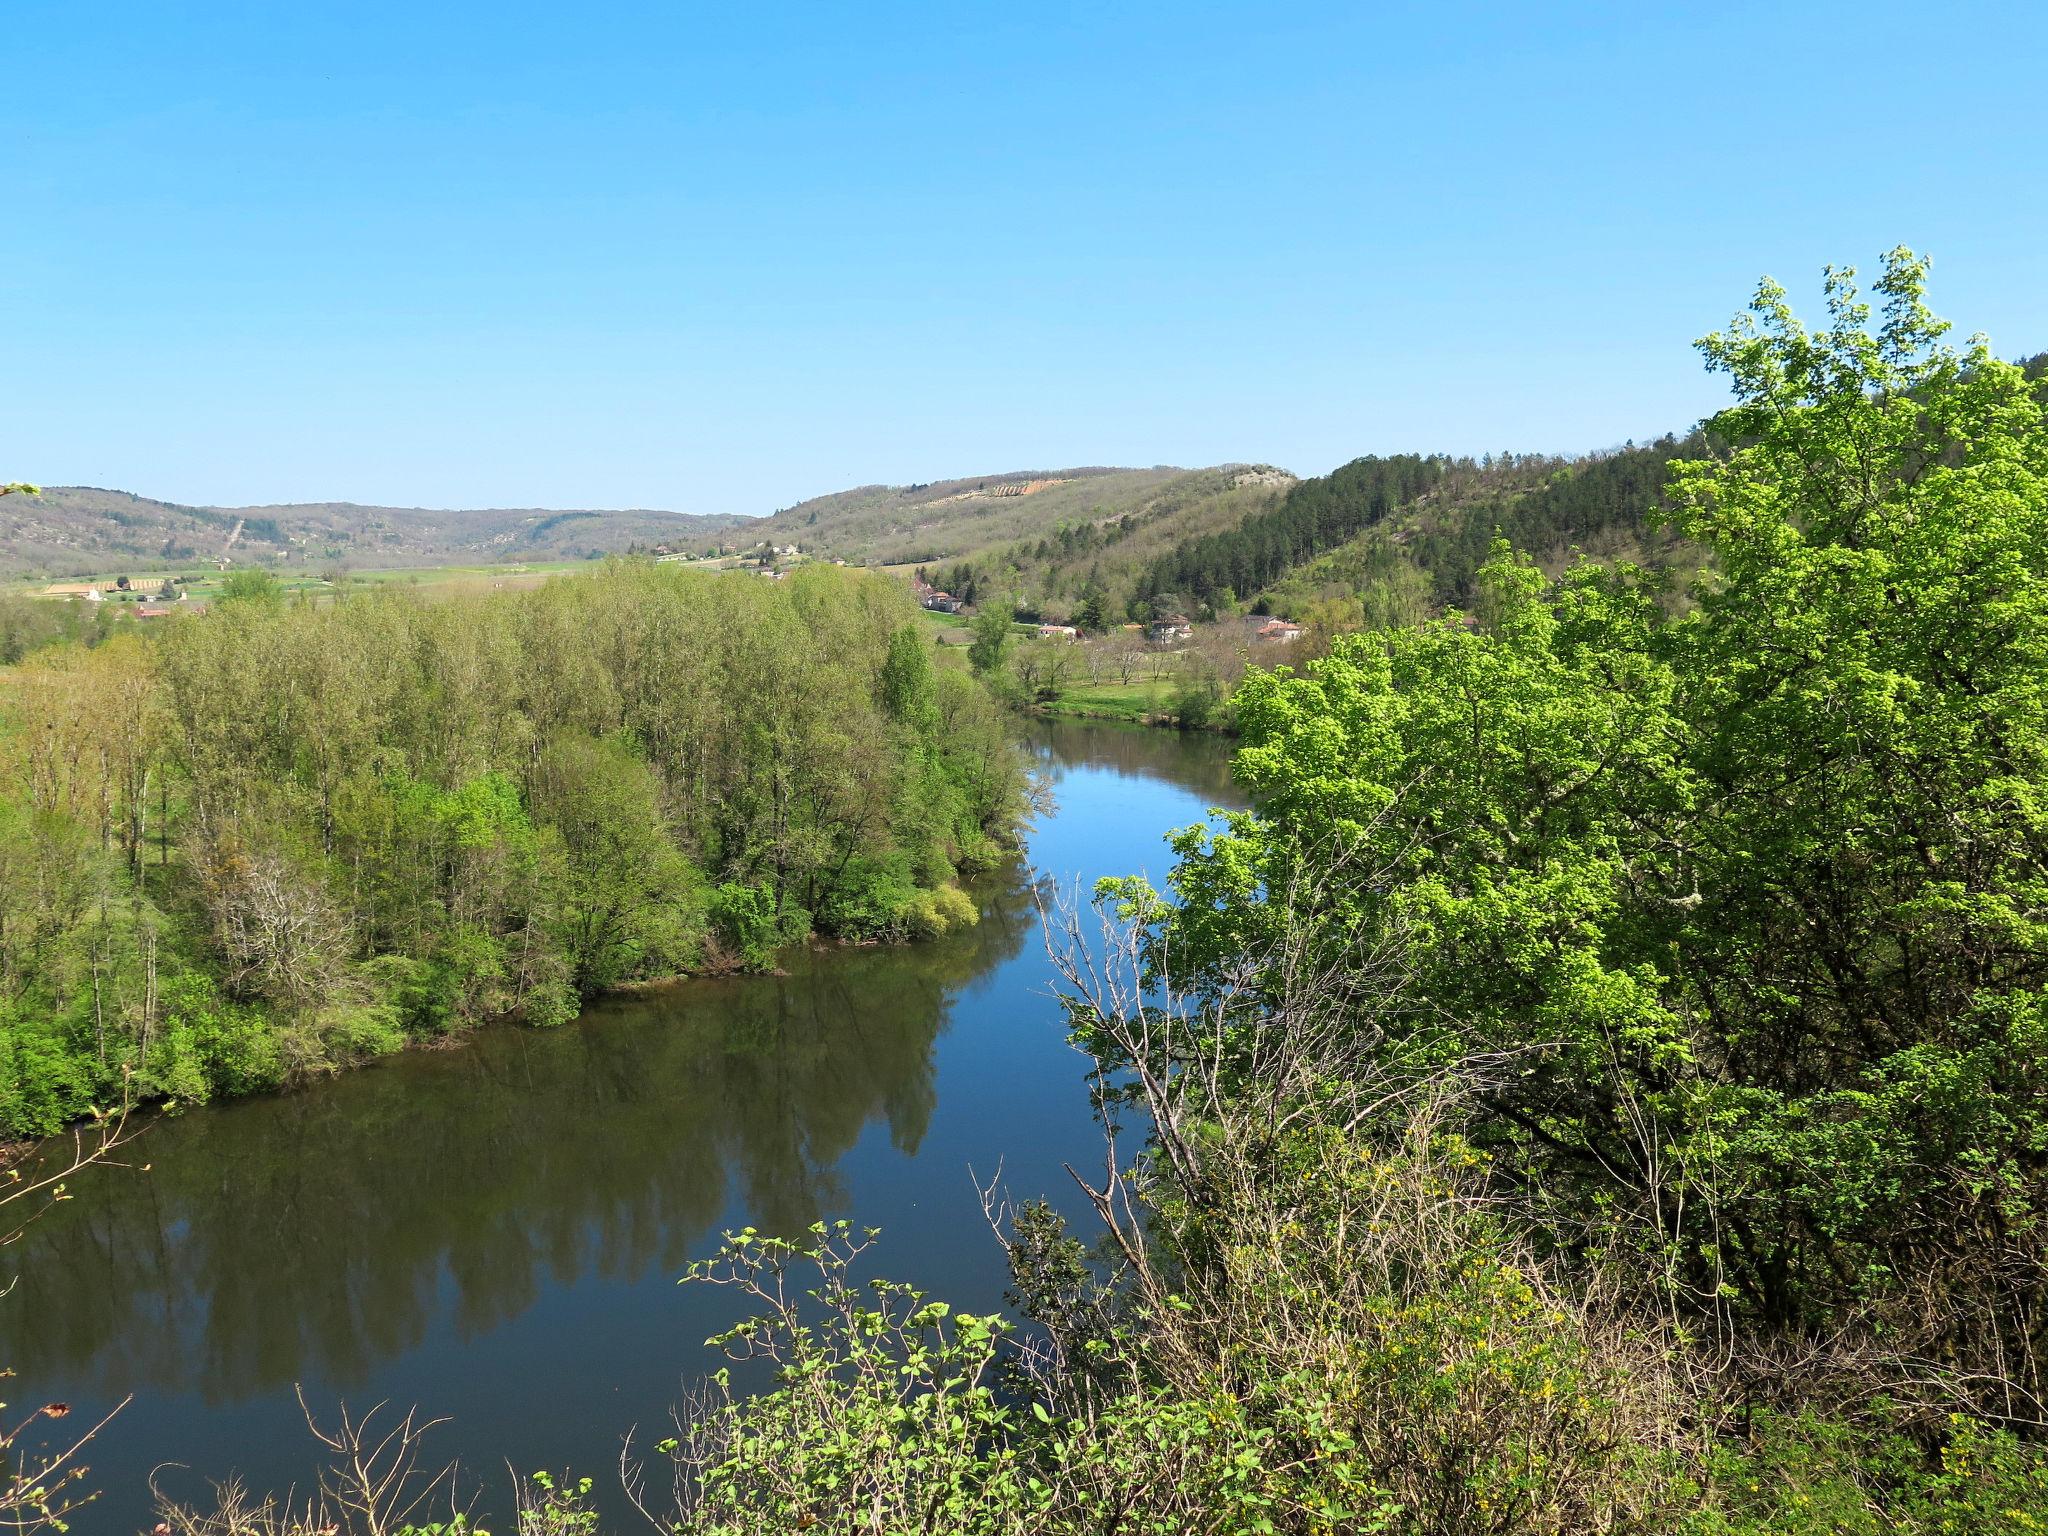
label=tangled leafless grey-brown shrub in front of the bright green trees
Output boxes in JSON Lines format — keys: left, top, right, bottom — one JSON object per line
{"left": 1024, "top": 872, "right": 1714, "bottom": 1532}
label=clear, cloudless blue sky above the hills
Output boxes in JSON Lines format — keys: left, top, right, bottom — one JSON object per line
{"left": 0, "top": 0, "right": 2048, "bottom": 512}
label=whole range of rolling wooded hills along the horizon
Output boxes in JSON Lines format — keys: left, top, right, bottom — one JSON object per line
{"left": 0, "top": 438, "right": 1698, "bottom": 618}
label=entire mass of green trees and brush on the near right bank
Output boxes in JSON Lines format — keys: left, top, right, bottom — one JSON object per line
{"left": 32, "top": 254, "right": 2048, "bottom": 1536}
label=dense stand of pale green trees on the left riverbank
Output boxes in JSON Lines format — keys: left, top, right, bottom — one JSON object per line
{"left": 0, "top": 561, "right": 1022, "bottom": 1137}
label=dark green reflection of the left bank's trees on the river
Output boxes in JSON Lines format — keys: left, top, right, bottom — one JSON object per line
{"left": 0, "top": 879, "right": 1036, "bottom": 1401}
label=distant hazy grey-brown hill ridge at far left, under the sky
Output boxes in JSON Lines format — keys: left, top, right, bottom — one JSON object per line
{"left": 0, "top": 485, "right": 748, "bottom": 575}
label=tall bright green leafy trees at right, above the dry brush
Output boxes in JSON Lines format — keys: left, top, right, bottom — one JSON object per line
{"left": 1146, "top": 254, "right": 2048, "bottom": 1417}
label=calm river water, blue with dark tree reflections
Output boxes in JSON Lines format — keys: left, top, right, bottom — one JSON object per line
{"left": 0, "top": 723, "right": 1239, "bottom": 1532}
